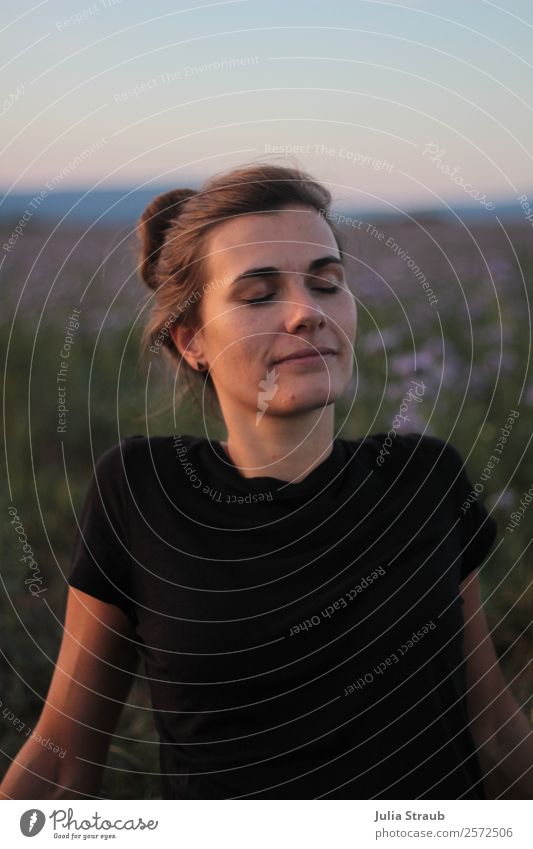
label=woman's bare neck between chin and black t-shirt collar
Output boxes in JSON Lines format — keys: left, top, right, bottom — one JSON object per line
{"left": 221, "top": 404, "right": 334, "bottom": 483}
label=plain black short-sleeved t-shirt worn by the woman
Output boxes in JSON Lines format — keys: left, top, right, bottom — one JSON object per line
{"left": 69, "top": 433, "right": 497, "bottom": 799}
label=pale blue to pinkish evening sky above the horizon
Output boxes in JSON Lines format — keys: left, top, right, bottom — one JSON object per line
{"left": 0, "top": 0, "right": 533, "bottom": 212}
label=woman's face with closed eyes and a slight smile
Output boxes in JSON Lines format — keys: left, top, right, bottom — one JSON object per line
{"left": 180, "top": 206, "right": 357, "bottom": 416}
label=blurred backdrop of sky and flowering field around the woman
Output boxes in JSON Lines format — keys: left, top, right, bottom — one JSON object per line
{"left": 0, "top": 0, "right": 533, "bottom": 798}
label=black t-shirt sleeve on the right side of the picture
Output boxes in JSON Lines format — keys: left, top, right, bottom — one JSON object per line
{"left": 430, "top": 442, "right": 498, "bottom": 581}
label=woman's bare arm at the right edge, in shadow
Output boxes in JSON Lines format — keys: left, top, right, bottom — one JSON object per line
{"left": 460, "top": 572, "right": 533, "bottom": 799}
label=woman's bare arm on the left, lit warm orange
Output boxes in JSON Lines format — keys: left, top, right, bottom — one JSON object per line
{"left": 0, "top": 587, "right": 138, "bottom": 799}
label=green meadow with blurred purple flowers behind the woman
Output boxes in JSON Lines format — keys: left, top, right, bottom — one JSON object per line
{"left": 0, "top": 214, "right": 533, "bottom": 799}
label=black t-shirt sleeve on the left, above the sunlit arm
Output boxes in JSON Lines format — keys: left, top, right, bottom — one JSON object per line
{"left": 67, "top": 443, "right": 133, "bottom": 620}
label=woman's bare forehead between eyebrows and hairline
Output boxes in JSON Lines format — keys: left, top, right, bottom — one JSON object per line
{"left": 208, "top": 205, "right": 339, "bottom": 276}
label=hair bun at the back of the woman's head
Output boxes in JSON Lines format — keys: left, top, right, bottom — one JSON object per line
{"left": 139, "top": 189, "right": 198, "bottom": 289}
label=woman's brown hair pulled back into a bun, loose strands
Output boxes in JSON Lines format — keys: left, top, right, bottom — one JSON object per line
{"left": 138, "top": 164, "right": 343, "bottom": 414}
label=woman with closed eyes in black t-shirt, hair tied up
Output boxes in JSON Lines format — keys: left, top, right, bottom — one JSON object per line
{"left": 1, "top": 165, "right": 532, "bottom": 799}
